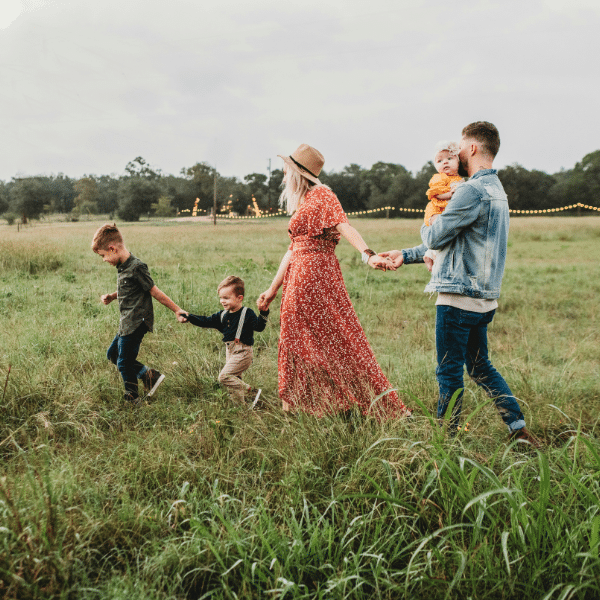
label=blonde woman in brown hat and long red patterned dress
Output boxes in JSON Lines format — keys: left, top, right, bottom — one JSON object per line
{"left": 257, "top": 144, "right": 410, "bottom": 418}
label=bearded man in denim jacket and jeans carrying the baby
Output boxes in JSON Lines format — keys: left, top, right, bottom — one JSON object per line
{"left": 381, "top": 121, "right": 539, "bottom": 447}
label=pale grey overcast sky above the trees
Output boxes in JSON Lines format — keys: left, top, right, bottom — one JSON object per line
{"left": 0, "top": 0, "right": 600, "bottom": 181}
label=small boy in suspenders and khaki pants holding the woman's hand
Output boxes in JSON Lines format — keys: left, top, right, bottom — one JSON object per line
{"left": 186, "top": 275, "right": 269, "bottom": 408}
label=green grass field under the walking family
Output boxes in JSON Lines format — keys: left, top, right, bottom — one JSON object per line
{"left": 0, "top": 217, "right": 600, "bottom": 600}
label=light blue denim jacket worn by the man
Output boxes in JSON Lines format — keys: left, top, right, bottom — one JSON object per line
{"left": 402, "top": 169, "right": 509, "bottom": 299}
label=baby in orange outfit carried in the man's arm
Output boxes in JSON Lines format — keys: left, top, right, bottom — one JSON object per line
{"left": 423, "top": 142, "right": 463, "bottom": 270}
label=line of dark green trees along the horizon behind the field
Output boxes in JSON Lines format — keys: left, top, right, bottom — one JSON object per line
{"left": 0, "top": 150, "right": 600, "bottom": 223}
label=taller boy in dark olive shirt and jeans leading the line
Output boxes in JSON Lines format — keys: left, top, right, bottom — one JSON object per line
{"left": 92, "top": 223, "right": 185, "bottom": 405}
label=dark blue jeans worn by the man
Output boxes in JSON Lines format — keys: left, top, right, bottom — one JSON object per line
{"left": 435, "top": 305, "right": 525, "bottom": 433}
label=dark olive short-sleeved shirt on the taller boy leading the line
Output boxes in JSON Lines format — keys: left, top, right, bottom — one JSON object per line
{"left": 117, "top": 254, "right": 154, "bottom": 336}
